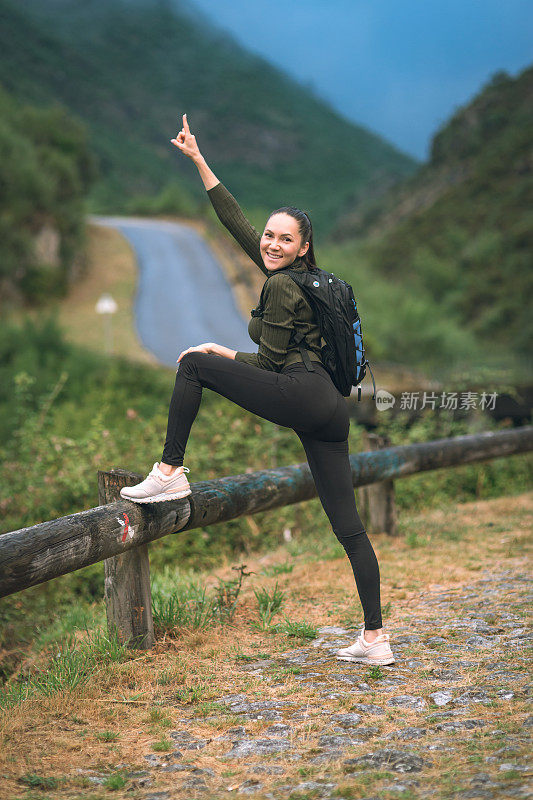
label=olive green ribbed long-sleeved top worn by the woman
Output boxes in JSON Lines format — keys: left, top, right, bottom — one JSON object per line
{"left": 207, "top": 183, "right": 320, "bottom": 372}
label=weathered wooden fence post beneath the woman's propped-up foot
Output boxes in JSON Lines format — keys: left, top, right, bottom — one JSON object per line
{"left": 98, "top": 469, "right": 155, "bottom": 650}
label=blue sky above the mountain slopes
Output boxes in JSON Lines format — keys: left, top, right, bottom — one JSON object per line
{"left": 187, "top": 0, "right": 533, "bottom": 160}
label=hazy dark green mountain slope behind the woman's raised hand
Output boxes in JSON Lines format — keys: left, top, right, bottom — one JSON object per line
{"left": 0, "top": 0, "right": 415, "bottom": 232}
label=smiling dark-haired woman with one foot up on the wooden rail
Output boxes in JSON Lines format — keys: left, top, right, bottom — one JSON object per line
{"left": 121, "top": 114, "right": 394, "bottom": 664}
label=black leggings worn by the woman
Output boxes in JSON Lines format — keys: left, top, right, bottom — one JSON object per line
{"left": 161, "top": 352, "right": 383, "bottom": 630}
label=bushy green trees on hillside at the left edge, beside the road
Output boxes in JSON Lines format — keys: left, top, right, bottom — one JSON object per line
{"left": 0, "top": 87, "right": 95, "bottom": 310}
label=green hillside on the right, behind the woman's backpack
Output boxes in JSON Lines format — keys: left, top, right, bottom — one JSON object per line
{"left": 336, "top": 68, "right": 533, "bottom": 361}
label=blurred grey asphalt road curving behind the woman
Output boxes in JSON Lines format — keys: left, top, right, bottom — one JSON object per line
{"left": 91, "top": 216, "right": 251, "bottom": 366}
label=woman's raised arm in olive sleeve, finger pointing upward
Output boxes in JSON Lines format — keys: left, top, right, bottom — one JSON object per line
{"left": 170, "top": 114, "right": 270, "bottom": 275}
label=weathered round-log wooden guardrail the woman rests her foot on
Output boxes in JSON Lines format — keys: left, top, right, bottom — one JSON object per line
{"left": 0, "top": 426, "right": 533, "bottom": 647}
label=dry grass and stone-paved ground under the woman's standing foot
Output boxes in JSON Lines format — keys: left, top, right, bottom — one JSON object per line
{"left": 0, "top": 494, "right": 533, "bottom": 800}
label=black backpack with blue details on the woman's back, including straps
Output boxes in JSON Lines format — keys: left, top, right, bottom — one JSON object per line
{"left": 252, "top": 267, "right": 376, "bottom": 400}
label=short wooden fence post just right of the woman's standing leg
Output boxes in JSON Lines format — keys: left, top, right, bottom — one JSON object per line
{"left": 357, "top": 431, "right": 398, "bottom": 536}
